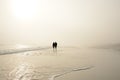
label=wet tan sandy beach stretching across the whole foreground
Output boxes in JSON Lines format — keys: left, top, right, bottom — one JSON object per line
{"left": 0, "top": 47, "right": 120, "bottom": 80}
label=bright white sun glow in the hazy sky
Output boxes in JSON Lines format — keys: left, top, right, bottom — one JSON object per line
{"left": 12, "top": 0, "right": 37, "bottom": 19}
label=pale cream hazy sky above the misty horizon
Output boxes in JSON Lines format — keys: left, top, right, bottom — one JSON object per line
{"left": 0, "top": 0, "right": 120, "bottom": 46}
